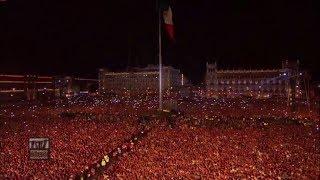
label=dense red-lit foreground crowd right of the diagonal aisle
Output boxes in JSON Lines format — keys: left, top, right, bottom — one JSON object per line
{"left": 109, "top": 117, "right": 320, "bottom": 179}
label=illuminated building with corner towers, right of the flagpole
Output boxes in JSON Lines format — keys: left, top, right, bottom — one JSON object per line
{"left": 206, "top": 61, "right": 304, "bottom": 97}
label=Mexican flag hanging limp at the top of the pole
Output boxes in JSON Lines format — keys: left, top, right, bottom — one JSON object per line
{"left": 160, "top": 0, "right": 175, "bottom": 41}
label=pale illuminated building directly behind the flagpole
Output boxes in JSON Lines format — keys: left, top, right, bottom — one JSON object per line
{"left": 99, "top": 65, "right": 182, "bottom": 94}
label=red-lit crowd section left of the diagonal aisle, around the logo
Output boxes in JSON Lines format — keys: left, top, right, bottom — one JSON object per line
{"left": 0, "top": 97, "right": 139, "bottom": 179}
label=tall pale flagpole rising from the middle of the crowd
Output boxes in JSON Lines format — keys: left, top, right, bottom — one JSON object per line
{"left": 157, "top": 0, "right": 162, "bottom": 110}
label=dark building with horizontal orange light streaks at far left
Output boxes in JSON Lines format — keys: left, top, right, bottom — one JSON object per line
{"left": 0, "top": 74, "right": 98, "bottom": 101}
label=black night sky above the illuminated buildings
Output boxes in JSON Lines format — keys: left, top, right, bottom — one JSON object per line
{"left": 0, "top": 0, "right": 320, "bottom": 82}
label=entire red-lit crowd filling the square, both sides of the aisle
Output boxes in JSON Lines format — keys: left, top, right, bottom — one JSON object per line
{"left": 0, "top": 93, "right": 320, "bottom": 179}
